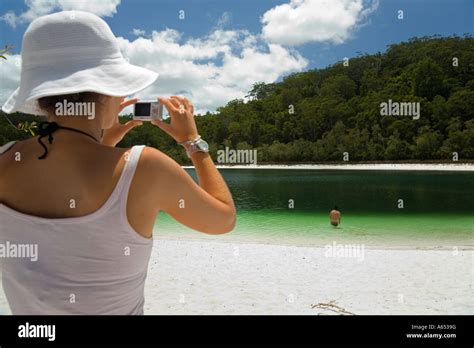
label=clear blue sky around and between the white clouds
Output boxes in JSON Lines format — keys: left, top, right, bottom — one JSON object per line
{"left": 0, "top": 0, "right": 474, "bottom": 68}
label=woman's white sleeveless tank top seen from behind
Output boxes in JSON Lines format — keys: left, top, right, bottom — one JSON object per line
{"left": 0, "top": 143, "right": 153, "bottom": 315}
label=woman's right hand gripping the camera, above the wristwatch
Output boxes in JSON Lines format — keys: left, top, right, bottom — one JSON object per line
{"left": 152, "top": 96, "right": 199, "bottom": 143}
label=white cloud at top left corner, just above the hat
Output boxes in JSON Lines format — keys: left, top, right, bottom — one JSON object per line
{"left": 0, "top": 0, "right": 121, "bottom": 27}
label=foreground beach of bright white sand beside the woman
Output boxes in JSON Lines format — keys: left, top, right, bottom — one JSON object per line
{"left": 0, "top": 239, "right": 474, "bottom": 315}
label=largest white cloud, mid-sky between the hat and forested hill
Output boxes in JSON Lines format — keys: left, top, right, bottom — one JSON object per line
{"left": 119, "top": 29, "right": 308, "bottom": 112}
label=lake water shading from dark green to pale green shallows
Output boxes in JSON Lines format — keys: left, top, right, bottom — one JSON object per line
{"left": 155, "top": 169, "right": 474, "bottom": 248}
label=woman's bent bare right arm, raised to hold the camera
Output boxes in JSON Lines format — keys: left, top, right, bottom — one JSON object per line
{"left": 140, "top": 97, "right": 236, "bottom": 234}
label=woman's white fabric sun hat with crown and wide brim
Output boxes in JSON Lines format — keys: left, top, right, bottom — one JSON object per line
{"left": 2, "top": 11, "right": 158, "bottom": 116}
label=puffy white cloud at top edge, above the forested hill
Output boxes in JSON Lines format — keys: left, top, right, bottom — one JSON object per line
{"left": 261, "top": 0, "right": 378, "bottom": 46}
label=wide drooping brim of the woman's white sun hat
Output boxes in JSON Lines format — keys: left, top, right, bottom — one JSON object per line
{"left": 2, "top": 58, "right": 158, "bottom": 116}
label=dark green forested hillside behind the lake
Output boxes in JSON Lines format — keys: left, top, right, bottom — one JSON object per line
{"left": 0, "top": 35, "right": 474, "bottom": 163}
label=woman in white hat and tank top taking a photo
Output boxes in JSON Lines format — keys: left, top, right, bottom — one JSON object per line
{"left": 0, "top": 11, "right": 236, "bottom": 314}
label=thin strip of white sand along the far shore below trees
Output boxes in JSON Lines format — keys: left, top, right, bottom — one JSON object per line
{"left": 182, "top": 163, "right": 474, "bottom": 172}
